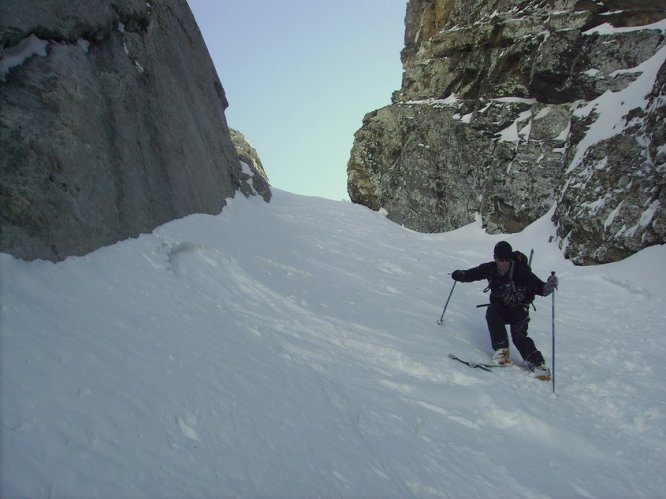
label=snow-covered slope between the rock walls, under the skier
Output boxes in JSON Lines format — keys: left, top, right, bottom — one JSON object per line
{"left": 0, "top": 190, "right": 666, "bottom": 498}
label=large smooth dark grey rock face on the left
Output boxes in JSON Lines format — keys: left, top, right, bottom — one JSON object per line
{"left": 0, "top": 0, "right": 267, "bottom": 261}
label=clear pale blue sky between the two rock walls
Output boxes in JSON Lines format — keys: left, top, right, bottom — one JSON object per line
{"left": 188, "top": 0, "right": 407, "bottom": 200}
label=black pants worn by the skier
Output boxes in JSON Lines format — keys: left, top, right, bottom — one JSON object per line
{"left": 486, "top": 303, "right": 544, "bottom": 365}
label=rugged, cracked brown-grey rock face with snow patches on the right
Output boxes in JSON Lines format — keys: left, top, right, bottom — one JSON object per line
{"left": 348, "top": 0, "right": 666, "bottom": 264}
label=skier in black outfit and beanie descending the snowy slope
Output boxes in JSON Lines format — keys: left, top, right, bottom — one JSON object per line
{"left": 451, "top": 241, "right": 558, "bottom": 381}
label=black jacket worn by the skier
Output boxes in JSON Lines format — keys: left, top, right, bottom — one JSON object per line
{"left": 459, "top": 260, "right": 549, "bottom": 307}
